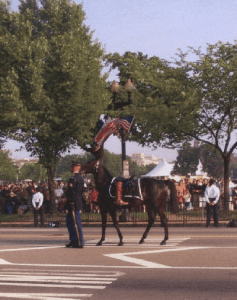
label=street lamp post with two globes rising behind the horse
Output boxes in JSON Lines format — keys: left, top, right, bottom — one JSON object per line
{"left": 111, "top": 79, "right": 135, "bottom": 178}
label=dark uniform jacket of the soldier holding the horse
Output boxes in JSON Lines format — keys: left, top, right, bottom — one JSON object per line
{"left": 64, "top": 173, "right": 84, "bottom": 211}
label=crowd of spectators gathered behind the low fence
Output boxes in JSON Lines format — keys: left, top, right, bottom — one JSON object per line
{"left": 0, "top": 178, "right": 237, "bottom": 214}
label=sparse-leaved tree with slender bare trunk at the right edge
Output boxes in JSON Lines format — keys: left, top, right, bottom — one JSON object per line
{"left": 169, "top": 42, "right": 237, "bottom": 210}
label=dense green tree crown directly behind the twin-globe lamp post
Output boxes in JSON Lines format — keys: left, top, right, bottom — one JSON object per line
{"left": 107, "top": 52, "right": 195, "bottom": 148}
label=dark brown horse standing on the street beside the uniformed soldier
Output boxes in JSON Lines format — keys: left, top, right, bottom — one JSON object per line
{"left": 81, "top": 149, "right": 179, "bottom": 246}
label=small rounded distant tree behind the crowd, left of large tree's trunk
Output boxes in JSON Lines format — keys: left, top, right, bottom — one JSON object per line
{"left": 18, "top": 163, "right": 47, "bottom": 181}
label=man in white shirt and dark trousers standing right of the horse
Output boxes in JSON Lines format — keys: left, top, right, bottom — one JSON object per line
{"left": 204, "top": 179, "right": 220, "bottom": 227}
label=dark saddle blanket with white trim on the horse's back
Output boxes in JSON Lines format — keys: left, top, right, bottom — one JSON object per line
{"left": 109, "top": 175, "right": 143, "bottom": 200}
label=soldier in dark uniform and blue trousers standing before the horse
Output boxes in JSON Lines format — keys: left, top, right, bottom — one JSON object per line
{"left": 64, "top": 162, "right": 84, "bottom": 248}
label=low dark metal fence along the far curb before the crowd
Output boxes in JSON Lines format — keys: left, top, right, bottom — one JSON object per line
{"left": 0, "top": 199, "right": 237, "bottom": 227}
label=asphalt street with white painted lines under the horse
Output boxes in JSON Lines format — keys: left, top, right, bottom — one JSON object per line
{"left": 0, "top": 227, "right": 237, "bottom": 300}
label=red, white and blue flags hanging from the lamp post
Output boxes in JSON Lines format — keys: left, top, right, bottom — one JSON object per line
{"left": 94, "top": 116, "right": 134, "bottom": 151}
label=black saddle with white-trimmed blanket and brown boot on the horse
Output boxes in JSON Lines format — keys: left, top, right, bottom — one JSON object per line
{"left": 109, "top": 175, "right": 143, "bottom": 205}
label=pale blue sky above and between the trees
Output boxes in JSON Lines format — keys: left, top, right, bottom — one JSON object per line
{"left": 5, "top": 0, "right": 237, "bottom": 162}
